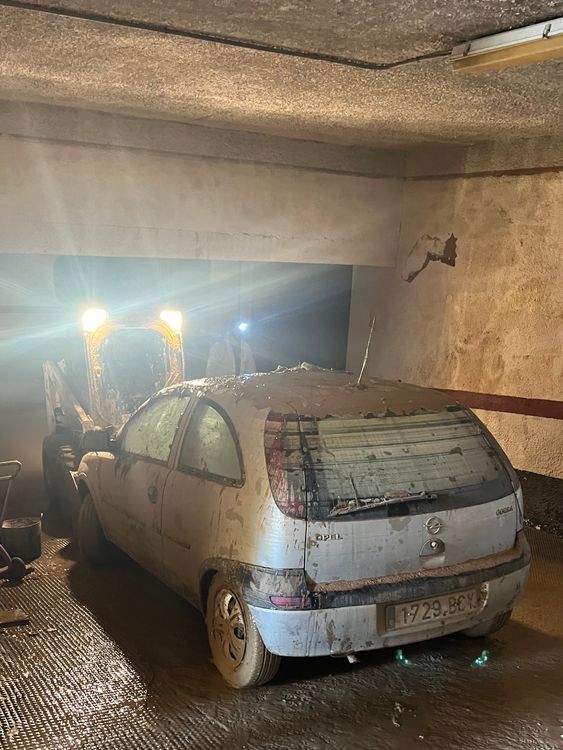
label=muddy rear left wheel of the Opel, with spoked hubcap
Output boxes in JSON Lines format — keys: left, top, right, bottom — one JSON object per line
{"left": 206, "top": 573, "right": 281, "bottom": 689}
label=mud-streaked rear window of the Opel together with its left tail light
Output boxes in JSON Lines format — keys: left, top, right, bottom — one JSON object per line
{"left": 265, "top": 408, "right": 513, "bottom": 519}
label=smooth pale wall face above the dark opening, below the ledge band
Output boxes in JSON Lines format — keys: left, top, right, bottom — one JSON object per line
{"left": 0, "top": 136, "right": 400, "bottom": 265}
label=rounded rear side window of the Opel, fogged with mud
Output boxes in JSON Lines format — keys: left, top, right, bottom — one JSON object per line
{"left": 179, "top": 402, "right": 243, "bottom": 484}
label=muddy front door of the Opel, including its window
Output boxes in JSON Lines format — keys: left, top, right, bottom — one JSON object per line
{"left": 101, "top": 394, "right": 189, "bottom": 576}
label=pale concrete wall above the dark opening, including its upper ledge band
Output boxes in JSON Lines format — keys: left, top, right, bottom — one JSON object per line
{"left": 0, "top": 101, "right": 403, "bottom": 265}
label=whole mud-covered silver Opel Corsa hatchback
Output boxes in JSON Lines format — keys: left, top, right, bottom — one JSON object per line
{"left": 76, "top": 369, "right": 529, "bottom": 687}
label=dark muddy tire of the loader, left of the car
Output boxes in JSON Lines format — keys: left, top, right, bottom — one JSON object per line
{"left": 43, "top": 434, "right": 80, "bottom": 524}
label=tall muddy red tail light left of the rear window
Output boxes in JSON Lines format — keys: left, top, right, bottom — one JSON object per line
{"left": 264, "top": 414, "right": 306, "bottom": 518}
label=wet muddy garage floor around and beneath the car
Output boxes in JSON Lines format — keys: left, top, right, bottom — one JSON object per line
{"left": 0, "top": 528, "right": 563, "bottom": 750}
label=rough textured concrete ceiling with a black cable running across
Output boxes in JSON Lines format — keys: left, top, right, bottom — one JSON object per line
{"left": 0, "top": 0, "right": 563, "bottom": 147}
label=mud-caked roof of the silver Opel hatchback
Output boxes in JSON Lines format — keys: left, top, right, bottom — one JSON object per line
{"left": 160, "top": 366, "right": 456, "bottom": 418}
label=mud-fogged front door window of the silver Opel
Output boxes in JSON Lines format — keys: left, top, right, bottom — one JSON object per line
{"left": 121, "top": 395, "right": 190, "bottom": 461}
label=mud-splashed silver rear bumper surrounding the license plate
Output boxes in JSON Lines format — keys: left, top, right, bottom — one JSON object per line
{"left": 249, "top": 533, "right": 530, "bottom": 656}
